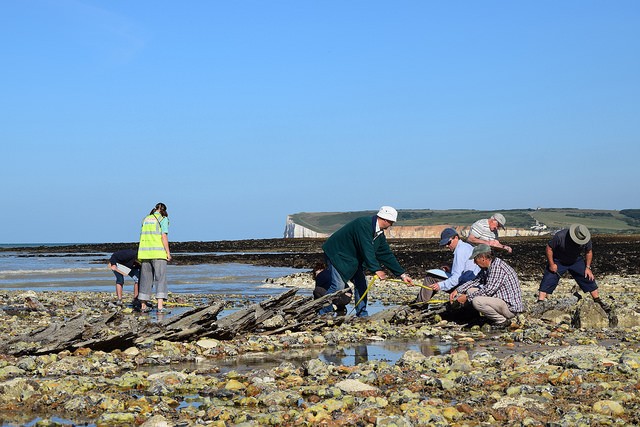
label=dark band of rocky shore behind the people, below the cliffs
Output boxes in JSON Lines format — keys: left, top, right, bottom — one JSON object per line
{"left": 0, "top": 234, "right": 640, "bottom": 280}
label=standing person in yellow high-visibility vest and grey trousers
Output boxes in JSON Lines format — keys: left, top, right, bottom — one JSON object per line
{"left": 138, "top": 203, "right": 171, "bottom": 313}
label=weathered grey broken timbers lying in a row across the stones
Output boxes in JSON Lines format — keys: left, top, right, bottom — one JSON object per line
{"left": 0, "top": 288, "right": 436, "bottom": 355}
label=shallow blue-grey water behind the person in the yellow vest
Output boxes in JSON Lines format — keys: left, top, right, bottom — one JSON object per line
{"left": 0, "top": 245, "right": 310, "bottom": 296}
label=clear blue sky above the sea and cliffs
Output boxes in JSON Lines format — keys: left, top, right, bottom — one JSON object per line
{"left": 0, "top": 0, "right": 640, "bottom": 243}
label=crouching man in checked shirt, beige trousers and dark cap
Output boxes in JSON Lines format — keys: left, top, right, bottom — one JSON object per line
{"left": 449, "top": 244, "right": 524, "bottom": 329}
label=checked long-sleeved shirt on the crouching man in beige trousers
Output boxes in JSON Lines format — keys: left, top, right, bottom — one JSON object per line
{"left": 458, "top": 258, "right": 524, "bottom": 313}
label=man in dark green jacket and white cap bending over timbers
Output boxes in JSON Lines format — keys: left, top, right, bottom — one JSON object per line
{"left": 319, "top": 206, "right": 413, "bottom": 317}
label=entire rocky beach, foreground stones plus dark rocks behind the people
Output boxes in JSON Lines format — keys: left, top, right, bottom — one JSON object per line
{"left": 0, "top": 236, "right": 640, "bottom": 426}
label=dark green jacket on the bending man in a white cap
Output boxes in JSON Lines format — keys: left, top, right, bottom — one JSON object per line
{"left": 322, "top": 216, "right": 404, "bottom": 282}
